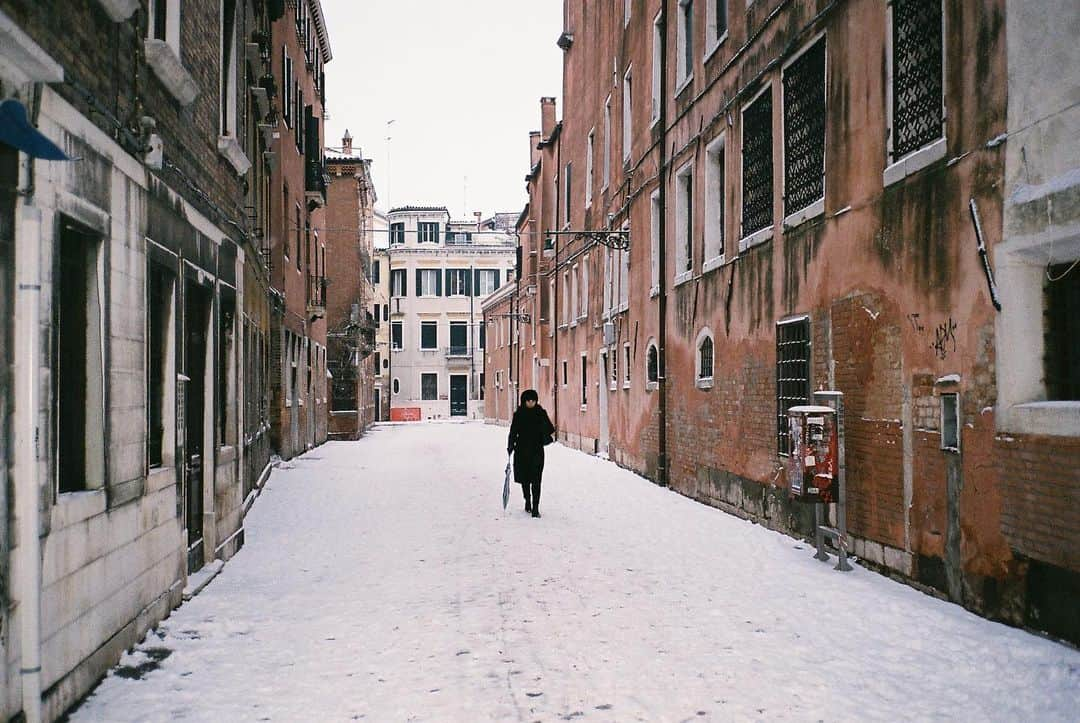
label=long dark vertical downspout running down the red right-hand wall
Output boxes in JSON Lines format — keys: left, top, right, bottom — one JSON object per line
{"left": 657, "top": 2, "right": 669, "bottom": 486}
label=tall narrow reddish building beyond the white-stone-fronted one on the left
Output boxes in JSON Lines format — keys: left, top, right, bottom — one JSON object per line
{"left": 268, "top": 0, "right": 333, "bottom": 459}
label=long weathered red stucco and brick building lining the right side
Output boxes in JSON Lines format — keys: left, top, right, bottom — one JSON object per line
{"left": 487, "top": 0, "right": 1080, "bottom": 640}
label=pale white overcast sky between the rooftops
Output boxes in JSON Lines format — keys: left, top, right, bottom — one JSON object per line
{"left": 322, "top": 0, "right": 563, "bottom": 218}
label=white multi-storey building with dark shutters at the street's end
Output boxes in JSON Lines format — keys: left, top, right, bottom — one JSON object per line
{"left": 380, "top": 206, "right": 516, "bottom": 420}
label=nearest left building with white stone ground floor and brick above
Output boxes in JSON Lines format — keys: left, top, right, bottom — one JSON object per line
{"left": 0, "top": 0, "right": 282, "bottom": 720}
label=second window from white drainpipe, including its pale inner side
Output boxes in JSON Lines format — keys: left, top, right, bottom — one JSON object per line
{"left": 146, "top": 263, "right": 176, "bottom": 467}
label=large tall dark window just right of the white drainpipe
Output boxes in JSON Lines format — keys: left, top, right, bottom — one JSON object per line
{"left": 52, "top": 220, "right": 105, "bottom": 493}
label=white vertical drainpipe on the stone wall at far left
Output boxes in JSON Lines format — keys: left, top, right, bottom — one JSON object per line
{"left": 15, "top": 197, "right": 42, "bottom": 723}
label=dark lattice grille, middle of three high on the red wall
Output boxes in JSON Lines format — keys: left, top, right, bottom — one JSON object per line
{"left": 784, "top": 37, "right": 825, "bottom": 215}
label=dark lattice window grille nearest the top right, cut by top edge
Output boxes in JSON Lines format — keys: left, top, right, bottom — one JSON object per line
{"left": 892, "top": 0, "right": 944, "bottom": 160}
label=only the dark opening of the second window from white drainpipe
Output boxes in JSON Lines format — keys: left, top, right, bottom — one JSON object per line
{"left": 147, "top": 264, "right": 173, "bottom": 467}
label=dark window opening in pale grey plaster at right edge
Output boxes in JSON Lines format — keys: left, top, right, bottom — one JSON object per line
{"left": 1043, "top": 262, "right": 1080, "bottom": 401}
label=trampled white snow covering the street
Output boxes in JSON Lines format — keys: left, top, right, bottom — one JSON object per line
{"left": 71, "top": 424, "right": 1080, "bottom": 722}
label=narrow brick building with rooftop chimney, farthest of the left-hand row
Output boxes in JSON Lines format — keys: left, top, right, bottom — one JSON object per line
{"left": 326, "top": 131, "right": 379, "bottom": 439}
